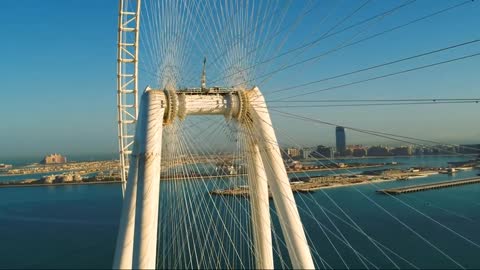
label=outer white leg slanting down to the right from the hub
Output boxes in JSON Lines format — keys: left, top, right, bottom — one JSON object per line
{"left": 248, "top": 87, "right": 315, "bottom": 269}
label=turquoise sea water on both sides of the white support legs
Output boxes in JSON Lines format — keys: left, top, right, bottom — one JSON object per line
{"left": 0, "top": 156, "right": 480, "bottom": 269}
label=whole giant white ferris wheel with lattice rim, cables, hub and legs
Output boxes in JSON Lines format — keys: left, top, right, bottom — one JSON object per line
{"left": 114, "top": 0, "right": 480, "bottom": 268}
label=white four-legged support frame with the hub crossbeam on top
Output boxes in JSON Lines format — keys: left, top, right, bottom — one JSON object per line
{"left": 113, "top": 87, "right": 314, "bottom": 269}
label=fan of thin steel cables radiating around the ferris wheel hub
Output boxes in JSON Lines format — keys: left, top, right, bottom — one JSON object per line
{"left": 128, "top": 0, "right": 480, "bottom": 269}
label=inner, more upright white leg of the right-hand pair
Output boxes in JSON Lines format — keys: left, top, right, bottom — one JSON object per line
{"left": 245, "top": 137, "right": 273, "bottom": 269}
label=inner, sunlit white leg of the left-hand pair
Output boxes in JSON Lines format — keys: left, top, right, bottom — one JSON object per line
{"left": 132, "top": 89, "right": 166, "bottom": 269}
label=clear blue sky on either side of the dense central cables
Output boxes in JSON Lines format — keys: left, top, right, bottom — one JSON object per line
{"left": 0, "top": 0, "right": 480, "bottom": 162}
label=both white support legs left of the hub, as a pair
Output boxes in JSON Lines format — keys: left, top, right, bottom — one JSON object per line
{"left": 113, "top": 89, "right": 165, "bottom": 269}
